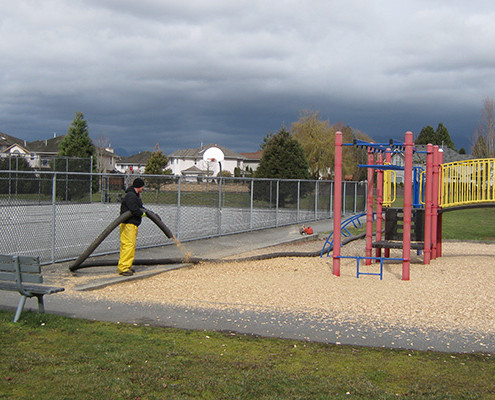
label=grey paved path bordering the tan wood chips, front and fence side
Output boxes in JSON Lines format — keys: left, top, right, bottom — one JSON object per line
{"left": 0, "top": 220, "right": 495, "bottom": 353}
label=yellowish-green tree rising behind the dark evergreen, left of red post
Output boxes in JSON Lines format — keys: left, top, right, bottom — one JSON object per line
{"left": 291, "top": 110, "right": 335, "bottom": 179}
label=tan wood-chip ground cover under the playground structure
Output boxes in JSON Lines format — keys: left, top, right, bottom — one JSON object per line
{"left": 64, "top": 241, "right": 495, "bottom": 334}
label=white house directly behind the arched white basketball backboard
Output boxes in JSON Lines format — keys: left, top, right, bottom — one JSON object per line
{"left": 167, "top": 144, "right": 245, "bottom": 176}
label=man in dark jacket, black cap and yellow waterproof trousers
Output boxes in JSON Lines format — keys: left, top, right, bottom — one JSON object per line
{"left": 117, "top": 178, "right": 146, "bottom": 276}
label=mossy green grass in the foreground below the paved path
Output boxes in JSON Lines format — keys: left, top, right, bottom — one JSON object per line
{"left": 0, "top": 311, "right": 495, "bottom": 399}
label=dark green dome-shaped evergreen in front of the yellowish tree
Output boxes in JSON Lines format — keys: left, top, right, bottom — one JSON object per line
{"left": 255, "top": 126, "right": 310, "bottom": 179}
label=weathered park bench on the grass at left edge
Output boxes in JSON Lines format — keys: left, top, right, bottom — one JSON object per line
{"left": 0, "top": 255, "right": 65, "bottom": 322}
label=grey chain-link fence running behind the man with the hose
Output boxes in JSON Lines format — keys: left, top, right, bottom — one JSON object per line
{"left": 0, "top": 171, "right": 366, "bottom": 264}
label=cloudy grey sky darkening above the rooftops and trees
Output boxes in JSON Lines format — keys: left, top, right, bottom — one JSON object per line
{"left": 0, "top": 0, "right": 495, "bottom": 155}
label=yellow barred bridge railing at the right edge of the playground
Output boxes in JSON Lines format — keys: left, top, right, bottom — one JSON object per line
{"left": 440, "top": 158, "right": 495, "bottom": 208}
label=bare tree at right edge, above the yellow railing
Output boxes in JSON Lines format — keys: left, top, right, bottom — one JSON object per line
{"left": 472, "top": 97, "right": 495, "bottom": 158}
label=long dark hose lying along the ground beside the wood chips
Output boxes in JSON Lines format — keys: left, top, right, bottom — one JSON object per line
{"left": 71, "top": 232, "right": 366, "bottom": 271}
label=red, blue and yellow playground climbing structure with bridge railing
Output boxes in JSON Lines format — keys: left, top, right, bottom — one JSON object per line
{"left": 321, "top": 132, "right": 495, "bottom": 280}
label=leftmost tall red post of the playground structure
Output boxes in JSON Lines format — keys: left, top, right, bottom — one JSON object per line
{"left": 332, "top": 132, "right": 342, "bottom": 276}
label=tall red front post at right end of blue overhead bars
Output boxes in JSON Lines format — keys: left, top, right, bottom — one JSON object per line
{"left": 402, "top": 132, "right": 414, "bottom": 281}
